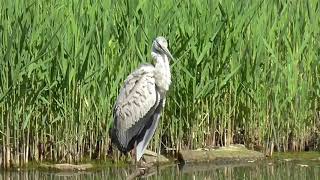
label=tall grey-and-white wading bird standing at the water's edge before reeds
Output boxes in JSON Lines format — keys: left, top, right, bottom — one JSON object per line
{"left": 110, "top": 36, "right": 173, "bottom": 162}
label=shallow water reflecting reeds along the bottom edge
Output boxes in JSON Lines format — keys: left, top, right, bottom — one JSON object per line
{"left": 0, "top": 159, "right": 320, "bottom": 180}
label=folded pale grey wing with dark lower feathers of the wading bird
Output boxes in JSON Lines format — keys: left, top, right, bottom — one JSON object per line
{"left": 114, "top": 65, "right": 160, "bottom": 152}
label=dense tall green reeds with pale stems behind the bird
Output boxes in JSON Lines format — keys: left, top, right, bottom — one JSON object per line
{"left": 0, "top": 0, "right": 320, "bottom": 167}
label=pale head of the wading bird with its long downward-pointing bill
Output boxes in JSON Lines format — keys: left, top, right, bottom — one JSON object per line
{"left": 152, "top": 36, "right": 173, "bottom": 59}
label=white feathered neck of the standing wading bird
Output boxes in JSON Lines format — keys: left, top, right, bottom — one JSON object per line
{"left": 152, "top": 54, "right": 171, "bottom": 93}
